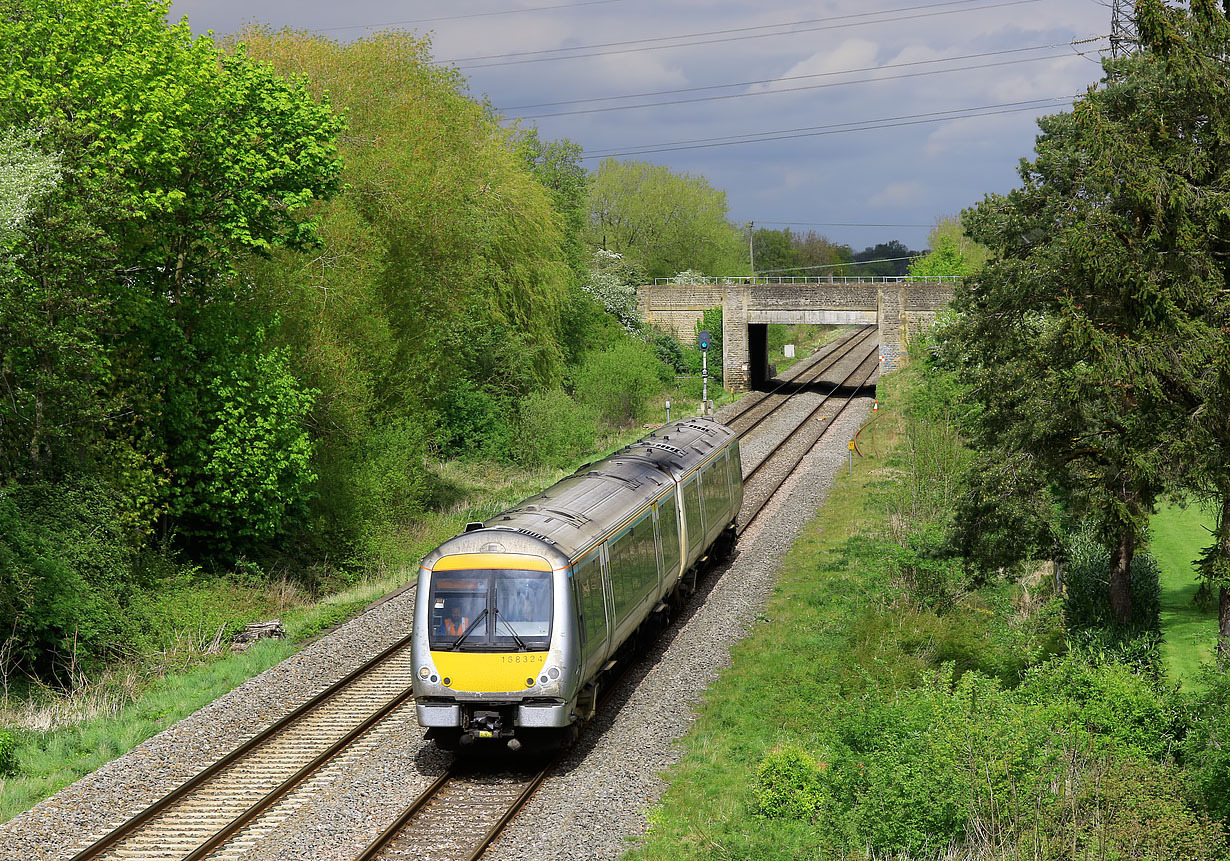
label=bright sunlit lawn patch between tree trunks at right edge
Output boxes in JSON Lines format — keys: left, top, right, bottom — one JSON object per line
{"left": 1149, "top": 506, "right": 1218, "bottom": 688}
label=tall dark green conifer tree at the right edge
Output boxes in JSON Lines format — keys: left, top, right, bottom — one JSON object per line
{"left": 939, "top": 0, "right": 1230, "bottom": 622}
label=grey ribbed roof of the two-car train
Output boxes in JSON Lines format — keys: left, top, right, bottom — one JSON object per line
{"left": 424, "top": 418, "right": 736, "bottom": 565}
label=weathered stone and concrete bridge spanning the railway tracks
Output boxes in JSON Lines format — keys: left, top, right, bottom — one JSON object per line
{"left": 637, "top": 276, "right": 959, "bottom": 391}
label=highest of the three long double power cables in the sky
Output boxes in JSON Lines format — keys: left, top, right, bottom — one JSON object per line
{"left": 442, "top": 0, "right": 1041, "bottom": 70}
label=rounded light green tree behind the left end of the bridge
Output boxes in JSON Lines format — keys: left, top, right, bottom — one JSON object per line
{"left": 585, "top": 159, "right": 747, "bottom": 278}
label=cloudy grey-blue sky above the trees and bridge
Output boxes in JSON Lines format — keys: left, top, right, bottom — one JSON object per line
{"left": 169, "top": 0, "right": 1112, "bottom": 260}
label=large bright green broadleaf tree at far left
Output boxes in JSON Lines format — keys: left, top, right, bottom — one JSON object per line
{"left": 0, "top": 0, "right": 341, "bottom": 530}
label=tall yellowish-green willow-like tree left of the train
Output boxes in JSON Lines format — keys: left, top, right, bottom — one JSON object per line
{"left": 236, "top": 28, "right": 575, "bottom": 551}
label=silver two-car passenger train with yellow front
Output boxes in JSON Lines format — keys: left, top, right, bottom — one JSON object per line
{"left": 411, "top": 417, "right": 743, "bottom": 750}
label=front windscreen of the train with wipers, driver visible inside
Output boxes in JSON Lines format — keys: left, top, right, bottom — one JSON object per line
{"left": 428, "top": 568, "right": 552, "bottom": 652}
